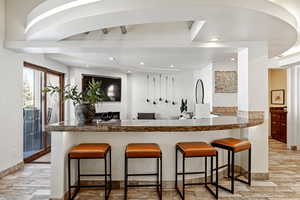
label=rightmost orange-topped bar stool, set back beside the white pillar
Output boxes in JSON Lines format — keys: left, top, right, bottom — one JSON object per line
{"left": 211, "top": 138, "right": 251, "bottom": 194}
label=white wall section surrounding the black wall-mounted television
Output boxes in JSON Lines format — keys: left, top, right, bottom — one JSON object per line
{"left": 70, "top": 68, "right": 128, "bottom": 119}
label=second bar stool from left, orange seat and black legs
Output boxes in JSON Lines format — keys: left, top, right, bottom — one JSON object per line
{"left": 124, "top": 143, "right": 162, "bottom": 199}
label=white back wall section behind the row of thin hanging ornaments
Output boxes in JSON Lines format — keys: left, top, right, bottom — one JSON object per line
{"left": 129, "top": 71, "right": 195, "bottom": 119}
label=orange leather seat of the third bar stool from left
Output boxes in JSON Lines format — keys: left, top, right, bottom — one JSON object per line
{"left": 176, "top": 142, "right": 217, "bottom": 157}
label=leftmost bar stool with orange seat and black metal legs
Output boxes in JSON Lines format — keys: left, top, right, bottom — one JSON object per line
{"left": 68, "top": 143, "right": 112, "bottom": 200}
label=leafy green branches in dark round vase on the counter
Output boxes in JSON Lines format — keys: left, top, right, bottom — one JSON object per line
{"left": 44, "top": 80, "right": 108, "bottom": 124}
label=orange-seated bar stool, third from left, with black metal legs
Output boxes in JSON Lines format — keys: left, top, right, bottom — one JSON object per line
{"left": 175, "top": 142, "right": 219, "bottom": 200}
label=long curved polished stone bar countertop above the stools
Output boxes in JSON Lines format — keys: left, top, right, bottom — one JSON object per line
{"left": 46, "top": 116, "right": 264, "bottom": 132}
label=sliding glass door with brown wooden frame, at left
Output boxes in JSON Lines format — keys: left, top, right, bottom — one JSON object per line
{"left": 23, "top": 62, "right": 64, "bottom": 163}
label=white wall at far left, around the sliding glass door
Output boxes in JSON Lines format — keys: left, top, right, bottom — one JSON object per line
{"left": 0, "top": 0, "right": 68, "bottom": 172}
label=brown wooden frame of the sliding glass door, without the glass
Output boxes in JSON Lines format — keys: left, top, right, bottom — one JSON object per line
{"left": 24, "top": 62, "right": 65, "bottom": 163}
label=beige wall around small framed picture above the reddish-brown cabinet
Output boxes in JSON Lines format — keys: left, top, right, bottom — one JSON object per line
{"left": 269, "top": 69, "right": 287, "bottom": 107}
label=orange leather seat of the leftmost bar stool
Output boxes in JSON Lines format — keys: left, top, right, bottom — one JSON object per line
{"left": 69, "top": 143, "right": 110, "bottom": 158}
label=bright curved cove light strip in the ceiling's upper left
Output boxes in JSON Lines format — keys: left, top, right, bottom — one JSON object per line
{"left": 25, "top": 0, "right": 102, "bottom": 33}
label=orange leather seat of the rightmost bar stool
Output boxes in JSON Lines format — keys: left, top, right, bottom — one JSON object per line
{"left": 211, "top": 138, "right": 251, "bottom": 152}
